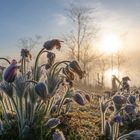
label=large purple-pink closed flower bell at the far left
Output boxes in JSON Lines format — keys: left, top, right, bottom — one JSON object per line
{"left": 3, "top": 59, "right": 18, "bottom": 83}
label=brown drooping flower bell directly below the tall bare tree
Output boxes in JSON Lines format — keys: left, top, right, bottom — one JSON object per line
{"left": 69, "top": 61, "right": 85, "bottom": 79}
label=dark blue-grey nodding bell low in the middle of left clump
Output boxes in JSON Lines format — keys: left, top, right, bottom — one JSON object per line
{"left": 35, "top": 82, "right": 48, "bottom": 100}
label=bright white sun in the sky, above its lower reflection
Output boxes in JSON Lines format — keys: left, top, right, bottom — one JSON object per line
{"left": 100, "top": 34, "right": 122, "bottom": 53}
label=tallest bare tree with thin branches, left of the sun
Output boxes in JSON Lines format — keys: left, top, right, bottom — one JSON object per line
{"left": 64, "top": 5, "right": 97, "bottom": 61}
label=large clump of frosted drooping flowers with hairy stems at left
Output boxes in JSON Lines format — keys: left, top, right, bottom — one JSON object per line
{"left": 0, "top": 39, "right": 86, "bottom": 140}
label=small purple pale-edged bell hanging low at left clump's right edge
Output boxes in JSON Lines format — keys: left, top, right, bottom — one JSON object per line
{"left": 74, "top": 92, "right": 85, "bottom": 106}
